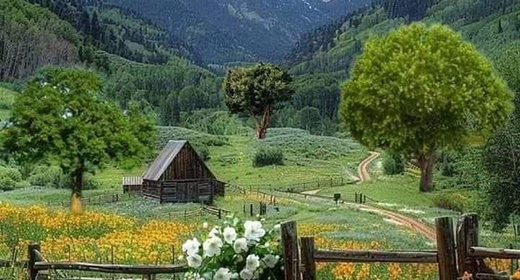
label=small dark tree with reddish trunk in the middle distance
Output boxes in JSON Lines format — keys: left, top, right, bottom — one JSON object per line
{"left": 223, "top": 63, "right": 293, "bottom": 139}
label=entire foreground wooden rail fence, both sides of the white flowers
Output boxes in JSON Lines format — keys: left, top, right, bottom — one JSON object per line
{"left": 5, "top": 214, "right": 520, "bottom": 280}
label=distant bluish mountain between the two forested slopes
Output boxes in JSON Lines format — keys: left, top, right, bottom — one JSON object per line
{"left": 106, "top": 0, "right": 372, "bottom": 64}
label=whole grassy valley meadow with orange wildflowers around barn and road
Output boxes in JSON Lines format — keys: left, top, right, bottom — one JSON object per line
{"left": 0, "top": 129, "right": 513, "bottom": 280}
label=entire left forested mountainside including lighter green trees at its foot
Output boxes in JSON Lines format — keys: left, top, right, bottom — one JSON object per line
{"left": 0, "top": 0, "right": 222, "bottom": 124}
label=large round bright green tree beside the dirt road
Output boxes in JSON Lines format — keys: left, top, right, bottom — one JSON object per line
{"left": 340, "top": 24, "right": 512, "bottom": 191}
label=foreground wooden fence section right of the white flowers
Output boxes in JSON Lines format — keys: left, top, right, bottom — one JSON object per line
{"left": 282, "top": 214, "right": 520, "bottom": 280}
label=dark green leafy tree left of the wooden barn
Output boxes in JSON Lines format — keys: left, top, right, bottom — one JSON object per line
{"left": 1, "top": 68, "right": 155, "bottom": 210}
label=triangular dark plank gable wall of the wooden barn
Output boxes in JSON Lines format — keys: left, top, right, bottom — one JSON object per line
{"left": 162, "top": 144, "right": 215, "bottom": 181}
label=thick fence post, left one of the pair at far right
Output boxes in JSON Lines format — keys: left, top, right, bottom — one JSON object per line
{"left": 435, "top": 217, "right": 457, "bottom": 280}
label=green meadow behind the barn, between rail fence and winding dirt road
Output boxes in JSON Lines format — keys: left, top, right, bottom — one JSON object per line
{"left": 207, "top": 129, "right": 366, "bottom": 187}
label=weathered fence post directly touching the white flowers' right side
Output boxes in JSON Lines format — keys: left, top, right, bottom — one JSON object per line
{"left": 282, "top": 222, "right": 300, "bottom": 280}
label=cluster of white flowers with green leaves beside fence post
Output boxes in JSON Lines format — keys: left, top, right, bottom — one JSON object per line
{"left": 182, "top": 218, "right": 283, "bottom": 280}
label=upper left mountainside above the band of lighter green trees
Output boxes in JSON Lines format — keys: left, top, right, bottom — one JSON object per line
{"left": 0, "top": 0, "right": 200, "bottom": 81}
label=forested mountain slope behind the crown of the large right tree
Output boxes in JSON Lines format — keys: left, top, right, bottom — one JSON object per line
{"left": 290, "top": 0, "right": 520, "bottom": 74}
